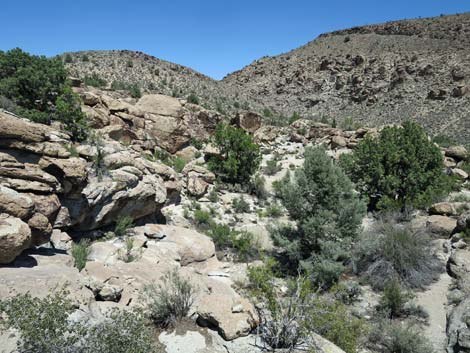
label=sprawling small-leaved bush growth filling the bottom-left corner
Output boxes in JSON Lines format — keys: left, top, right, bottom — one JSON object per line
{"left": 0, "top": 292, "right": 156, "bottom": 353}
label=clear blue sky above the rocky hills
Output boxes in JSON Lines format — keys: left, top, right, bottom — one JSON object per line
{"left": 0, "top": 0, "right": 470, "bottom": 79}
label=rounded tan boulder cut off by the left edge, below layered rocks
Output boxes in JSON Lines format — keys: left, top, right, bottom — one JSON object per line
{"left": 0, "top": 213, "right": 31, "bottom": 264}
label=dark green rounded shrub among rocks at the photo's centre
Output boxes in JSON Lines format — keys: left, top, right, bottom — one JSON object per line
{"left": 208, "top": 124, "right": 261, "bottom": 183}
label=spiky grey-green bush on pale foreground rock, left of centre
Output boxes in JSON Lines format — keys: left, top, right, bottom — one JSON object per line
{"left": 143, "top": 269, "right": 196, "bottom": 327}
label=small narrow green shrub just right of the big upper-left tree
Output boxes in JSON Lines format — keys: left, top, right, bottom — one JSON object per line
{"left": 54, "top": 87, "right": 88, "bottom": 142}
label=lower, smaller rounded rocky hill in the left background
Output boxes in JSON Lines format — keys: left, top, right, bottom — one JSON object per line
{"left": 63, "top": 50, "right": 261, "bottom": 112}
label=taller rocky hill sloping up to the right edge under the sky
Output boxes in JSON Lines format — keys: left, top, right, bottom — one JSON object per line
{"left": 223, "top": 13, "right": 470, "bottom": 140}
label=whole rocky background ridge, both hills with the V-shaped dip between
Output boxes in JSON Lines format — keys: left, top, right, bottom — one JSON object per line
{"left": 67, "top": 13, "right": 470, "bottom": 141}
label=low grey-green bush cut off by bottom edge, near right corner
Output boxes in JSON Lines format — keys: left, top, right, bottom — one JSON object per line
{"left": 369, "top": 320, "right": 434, "bottom": 353}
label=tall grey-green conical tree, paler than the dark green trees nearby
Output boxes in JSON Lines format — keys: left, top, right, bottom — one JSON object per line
{"left": 275, "top": 148, "right": 365, "bottom": 282}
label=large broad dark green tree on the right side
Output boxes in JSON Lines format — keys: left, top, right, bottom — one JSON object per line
{"left": 341, "top": 122, "right": 451, "bottom": 210}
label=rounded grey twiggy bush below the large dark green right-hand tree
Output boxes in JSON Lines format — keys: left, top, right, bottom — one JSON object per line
{"left": 353, "top": 218, "right": 442, "bottom": 289}
